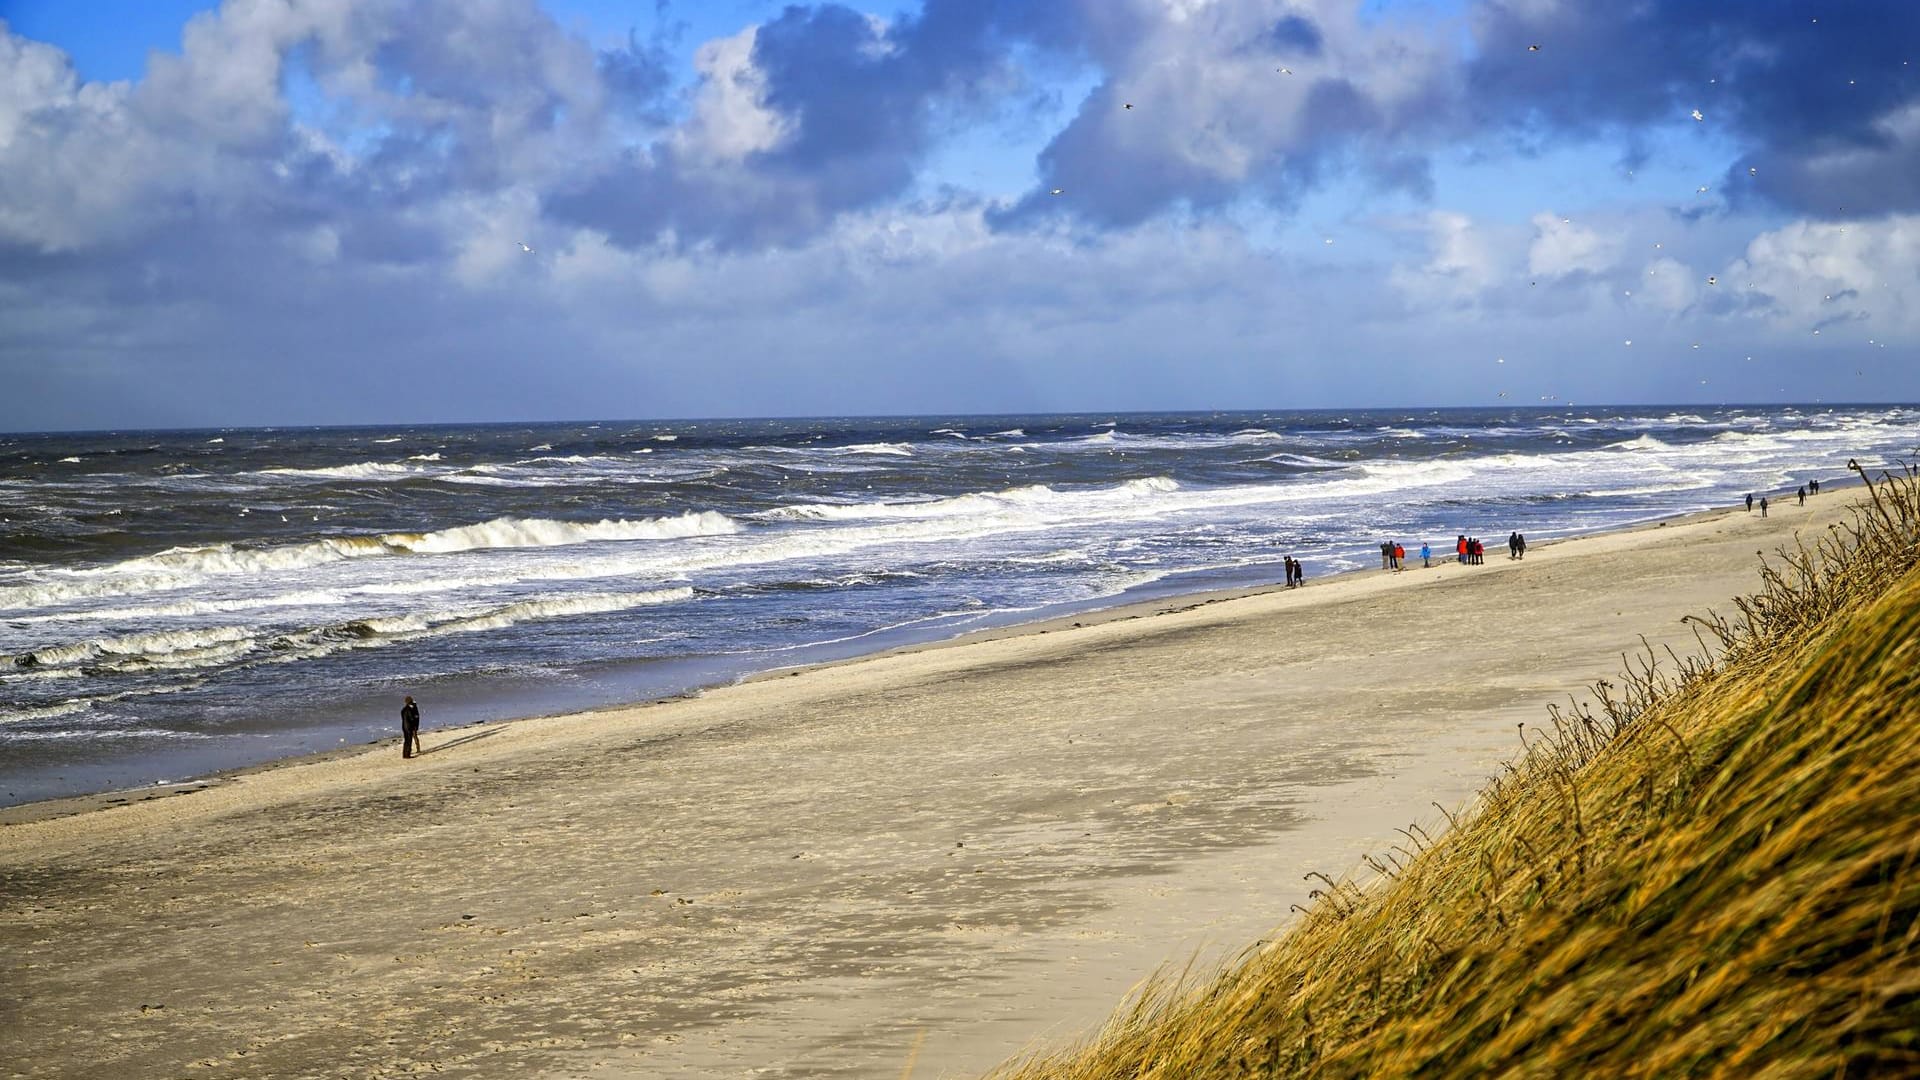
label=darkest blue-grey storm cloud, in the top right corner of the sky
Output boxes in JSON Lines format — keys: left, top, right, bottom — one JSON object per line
{"left": 1467, "top": 0, "right": 1920, "bottom": 215}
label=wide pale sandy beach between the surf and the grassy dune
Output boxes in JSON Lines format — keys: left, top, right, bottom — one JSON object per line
{"left": 0, "top": 494, "right": 1845, "bottom": 1078}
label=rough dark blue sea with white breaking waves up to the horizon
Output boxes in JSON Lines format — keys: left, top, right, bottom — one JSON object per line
{"left": 0, "top": 405, "right": 1920, "bottom": 805}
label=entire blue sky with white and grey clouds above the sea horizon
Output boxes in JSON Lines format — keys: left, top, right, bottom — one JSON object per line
{"left": 0, "top": 0, "right": 1920, "bottom": 430}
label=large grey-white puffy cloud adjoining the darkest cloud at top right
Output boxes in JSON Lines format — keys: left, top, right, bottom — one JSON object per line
{"left": 993, "top": 2, "right": 1455, "bottom": 229}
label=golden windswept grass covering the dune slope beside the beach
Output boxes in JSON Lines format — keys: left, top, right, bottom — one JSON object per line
{"left": 995, "top": 469, "right": 1920, "bottom": 1080}
